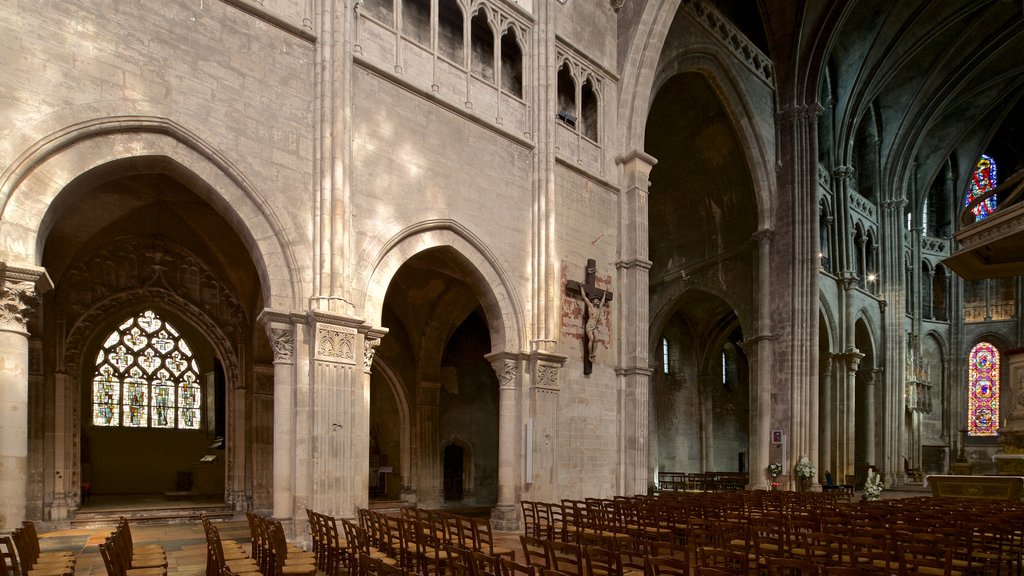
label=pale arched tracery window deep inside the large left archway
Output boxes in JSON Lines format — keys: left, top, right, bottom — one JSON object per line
{"left": 92, "top": 311, "right": 203, "bottom": 429}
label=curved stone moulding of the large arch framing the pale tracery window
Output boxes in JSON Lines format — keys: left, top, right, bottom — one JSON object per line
{"left": 0, "top": 116, "right": 303, "bottom": 310}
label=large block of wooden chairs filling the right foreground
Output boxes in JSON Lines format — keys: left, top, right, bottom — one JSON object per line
{"left": 520, "top": 491, "right": 1024, "bottom": 576}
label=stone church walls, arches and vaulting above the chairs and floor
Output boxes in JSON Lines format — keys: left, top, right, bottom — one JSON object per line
{"left": 0, "top": 0, "right": 1024, "bottom": 531}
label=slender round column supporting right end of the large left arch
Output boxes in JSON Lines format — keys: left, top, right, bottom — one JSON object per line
{"left": 259, "top": 310, "right": 296, "bottom": 518}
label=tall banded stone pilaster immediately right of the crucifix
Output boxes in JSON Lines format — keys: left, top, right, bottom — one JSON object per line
{"left": 615, "top": 151, "right": 657, "bottom": 494}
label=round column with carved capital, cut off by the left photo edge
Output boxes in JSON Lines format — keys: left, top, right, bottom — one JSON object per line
{"left": 0, "top": 262, "right": 50, "bottom": 531}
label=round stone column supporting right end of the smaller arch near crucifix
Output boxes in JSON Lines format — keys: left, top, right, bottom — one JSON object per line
{"left": 487, "top": 353, "right": 522, "bottom": 532}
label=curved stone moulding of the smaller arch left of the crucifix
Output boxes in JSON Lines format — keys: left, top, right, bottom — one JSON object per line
{"left": 356, "top": 219, "right": 526, "bottom": 352}
